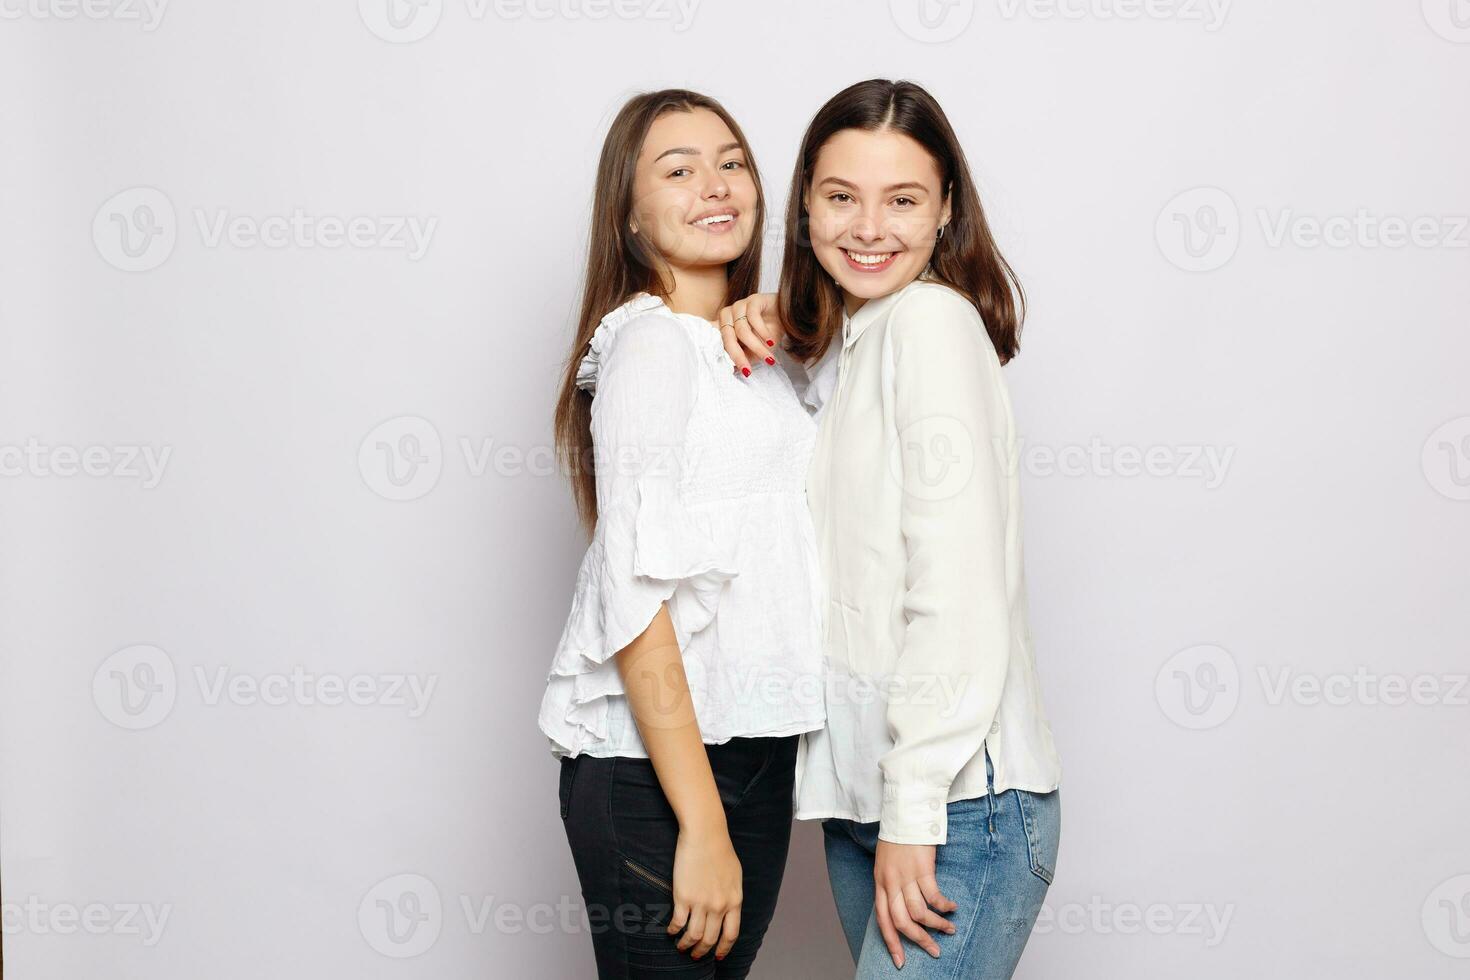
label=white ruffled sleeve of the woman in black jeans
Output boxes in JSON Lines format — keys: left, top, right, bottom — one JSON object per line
{"left": 541, "top": 307, "right": 736, "bottom": 754}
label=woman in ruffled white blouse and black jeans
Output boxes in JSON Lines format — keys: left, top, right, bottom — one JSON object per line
{"left": 539, "top": 91, "right": 826, "bottom": 980}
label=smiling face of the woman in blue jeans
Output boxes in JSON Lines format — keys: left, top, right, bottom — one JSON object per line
{"left": 806, "top": 129, "right": 950, "bottom": 313}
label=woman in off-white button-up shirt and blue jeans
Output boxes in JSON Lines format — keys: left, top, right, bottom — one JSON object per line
{"left": 726, "top": 79, "right": 1061, "bottom": 980}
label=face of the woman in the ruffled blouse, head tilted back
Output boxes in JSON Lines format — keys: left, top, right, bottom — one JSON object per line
{"left": 631, "top": 109, "right": 757, "bottom": 276}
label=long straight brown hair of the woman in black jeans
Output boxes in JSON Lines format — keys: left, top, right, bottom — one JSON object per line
{"left": 553, "top": 88, "right": 766, "bottom": 535}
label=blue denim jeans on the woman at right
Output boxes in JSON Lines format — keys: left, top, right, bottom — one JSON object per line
{"left": 822, "top": 755, "right": 1061, "bottom": 980}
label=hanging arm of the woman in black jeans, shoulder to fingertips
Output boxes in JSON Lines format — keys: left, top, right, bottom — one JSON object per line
{"left": 592, "top": 316, "right": 742, "bottom": 958}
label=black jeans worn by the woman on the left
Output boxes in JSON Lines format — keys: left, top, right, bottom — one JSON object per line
{"left": 560, "top": 735, "right": 800, "bottom": 980}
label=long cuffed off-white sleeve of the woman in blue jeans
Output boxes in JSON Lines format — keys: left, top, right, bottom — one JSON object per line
{"left": 879, "top": 288, "right": 1013, "bottom": 845}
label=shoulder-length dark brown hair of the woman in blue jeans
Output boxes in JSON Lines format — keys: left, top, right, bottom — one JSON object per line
{"left": 779, "top": 78, "right": 1026, "bottom": 364}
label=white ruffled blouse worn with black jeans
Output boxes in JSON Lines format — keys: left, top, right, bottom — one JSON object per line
{"left": 539, "top": 294, "right": 826, "bottom": 758}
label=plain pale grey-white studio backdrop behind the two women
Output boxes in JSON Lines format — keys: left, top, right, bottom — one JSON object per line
{"left": 0, "top": 0, "right": 1470, "bottom": 980}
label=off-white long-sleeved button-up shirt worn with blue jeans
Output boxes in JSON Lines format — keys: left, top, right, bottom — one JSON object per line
{"left": 794, "top": 279, "right": 1061, "bottom": 843}
